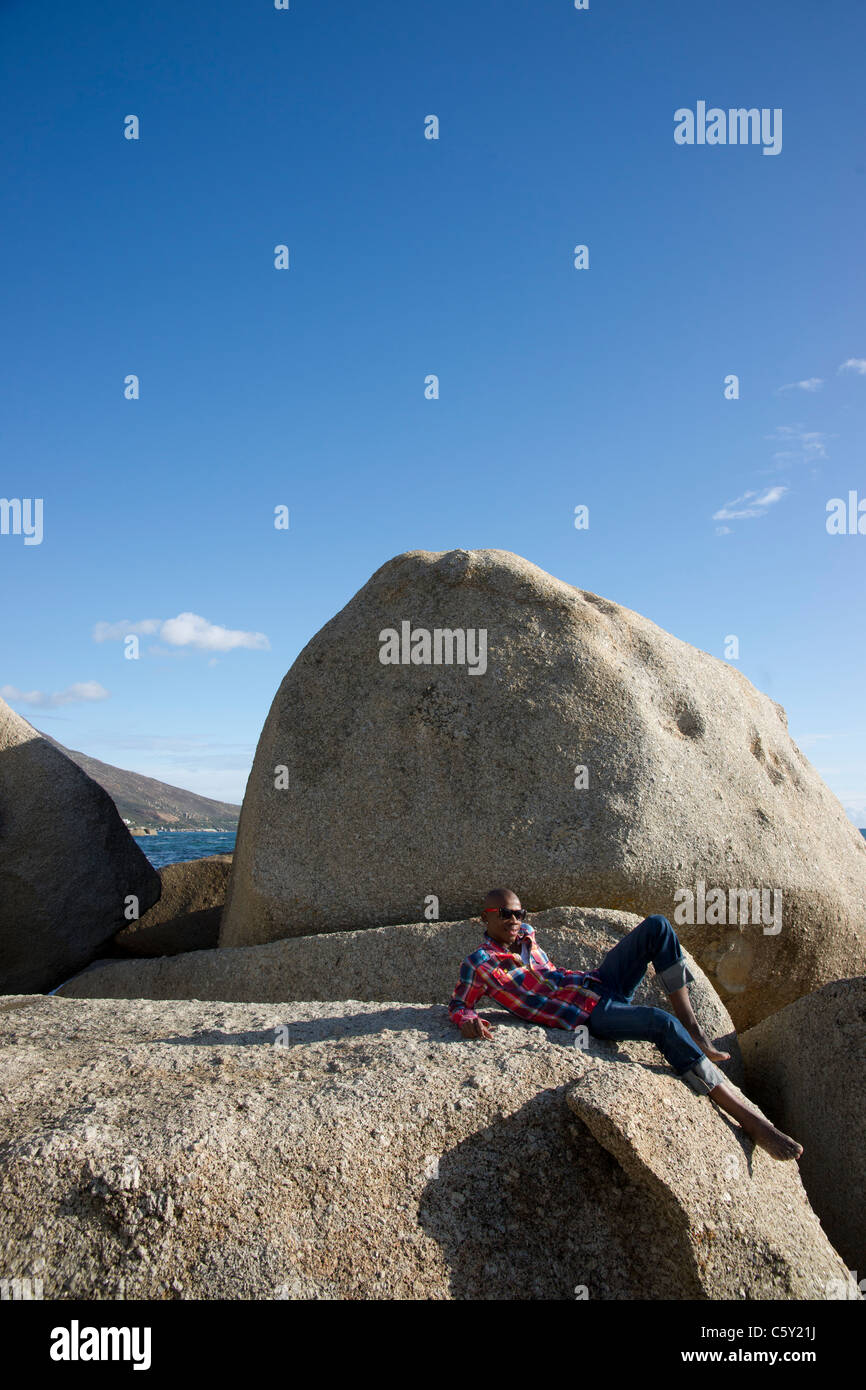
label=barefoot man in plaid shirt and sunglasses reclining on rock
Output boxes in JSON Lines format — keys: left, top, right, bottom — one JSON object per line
{"left": 448, "top": 888, "right": 803, "bottom": 1159}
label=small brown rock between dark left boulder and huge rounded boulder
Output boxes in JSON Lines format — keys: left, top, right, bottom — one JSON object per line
{"left": 114, "top": 855, "right": 232, "bottom": 956}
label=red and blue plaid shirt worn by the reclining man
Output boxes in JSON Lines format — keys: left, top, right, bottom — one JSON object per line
{"left": 448, "top": 923, "right": 601, "bottom": 1029}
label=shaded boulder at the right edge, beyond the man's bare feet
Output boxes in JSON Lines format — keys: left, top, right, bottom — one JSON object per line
{"left": 741, "top": 976, "right": 866, "bottom": 1277}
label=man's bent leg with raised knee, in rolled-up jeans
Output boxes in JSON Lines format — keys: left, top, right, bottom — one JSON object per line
{"left": 599, "top": 913, "right": 731, "bottom": 1062}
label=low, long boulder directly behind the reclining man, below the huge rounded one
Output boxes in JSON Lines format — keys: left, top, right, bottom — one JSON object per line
{"left": 58, "top": 908, "right": 742, "bottom": 1084}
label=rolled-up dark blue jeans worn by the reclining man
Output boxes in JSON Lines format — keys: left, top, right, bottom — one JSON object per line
{"left": 587, "top": 916, "right": 724, "bottom": 1095}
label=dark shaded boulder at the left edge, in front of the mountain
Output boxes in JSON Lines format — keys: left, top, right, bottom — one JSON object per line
{"left": 0, "top": 699, "right": 160, "bottom": 994}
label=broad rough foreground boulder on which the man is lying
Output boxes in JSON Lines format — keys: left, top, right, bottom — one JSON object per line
{"left": 0, "top": 998, "right": 849, "bottom": 1301}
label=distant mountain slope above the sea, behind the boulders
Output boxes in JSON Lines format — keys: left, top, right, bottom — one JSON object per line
{"left": 40, "top": 730, "right": 240, "bottom": 830}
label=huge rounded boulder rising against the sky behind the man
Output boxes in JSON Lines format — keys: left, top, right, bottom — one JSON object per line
{"left": 221, "top": 550, "right": 866, "bottom": 1027}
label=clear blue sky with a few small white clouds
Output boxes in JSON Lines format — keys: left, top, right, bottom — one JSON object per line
{"left": 0, "top": 0, "right": 866, "bottom": 824}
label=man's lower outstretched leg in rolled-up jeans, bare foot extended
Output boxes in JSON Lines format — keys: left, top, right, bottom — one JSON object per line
{"left": 587, "top": 998, "right": 803, "bottom": 1159}
